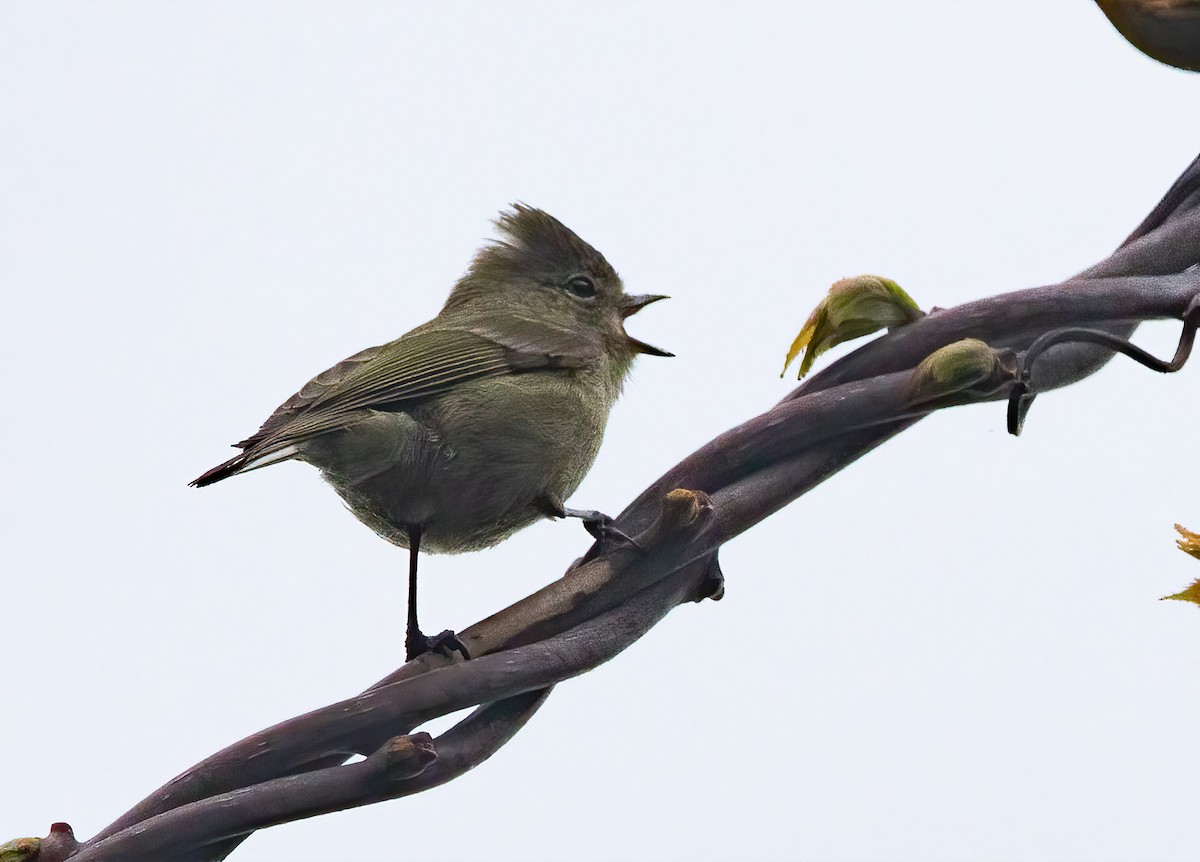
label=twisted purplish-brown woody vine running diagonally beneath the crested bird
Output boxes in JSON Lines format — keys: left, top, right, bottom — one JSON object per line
{"left": 25, "top": 151, "right": 1200, "bottom": 862}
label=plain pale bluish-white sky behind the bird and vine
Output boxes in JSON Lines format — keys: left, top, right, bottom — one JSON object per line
{"left": 0, "top": 0, "right": 1200, "bottom": 862}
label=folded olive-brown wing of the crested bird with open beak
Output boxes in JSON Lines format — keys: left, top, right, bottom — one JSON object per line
{"left": 236, "top": 317, "right": 602, "bottom": 450}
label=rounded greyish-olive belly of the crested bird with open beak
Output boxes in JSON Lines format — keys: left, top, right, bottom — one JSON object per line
{"left": 305, "top": 377, "right": 607, "bottom": 553}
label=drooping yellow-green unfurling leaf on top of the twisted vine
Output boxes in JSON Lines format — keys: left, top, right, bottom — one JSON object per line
{"left": 779, "top": 275, "right": 925, "bottom": 377}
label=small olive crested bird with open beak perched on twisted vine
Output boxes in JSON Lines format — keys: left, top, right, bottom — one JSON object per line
{"left": 191, "top": 204, "right": 672, "bottom": 659}
